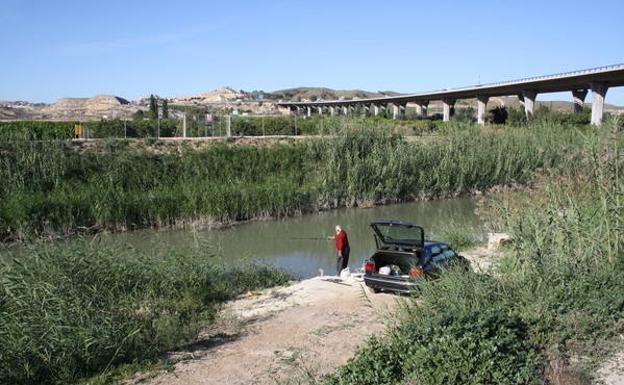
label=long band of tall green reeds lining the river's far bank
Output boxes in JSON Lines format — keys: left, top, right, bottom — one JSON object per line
{"left": 0, "top": 121, "right": 582, "bottom": 241}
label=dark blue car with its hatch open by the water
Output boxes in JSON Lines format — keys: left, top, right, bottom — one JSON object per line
{"left": 364, "top": 221, "right": 469, "bottom": 293}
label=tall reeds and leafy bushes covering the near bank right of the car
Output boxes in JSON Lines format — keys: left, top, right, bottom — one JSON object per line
{"left": 322, "top": 124, "right": 624, "bottom": 385}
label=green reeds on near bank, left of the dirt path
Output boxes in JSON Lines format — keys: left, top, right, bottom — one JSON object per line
{"left": 0, "top": 242, "right": 289, "bottom": 384}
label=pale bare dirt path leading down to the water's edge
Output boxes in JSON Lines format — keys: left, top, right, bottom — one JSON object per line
{"left": 142, "top": 277, "right": 402, "bottom": 385}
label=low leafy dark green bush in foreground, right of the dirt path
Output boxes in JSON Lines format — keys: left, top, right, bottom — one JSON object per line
{"left": 323, "top": 271, "right": 539, "bottom": 385}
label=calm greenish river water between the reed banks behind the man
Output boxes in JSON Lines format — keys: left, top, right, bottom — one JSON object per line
{"left": 103, "top": 199, "right": 483, "bottom": 278}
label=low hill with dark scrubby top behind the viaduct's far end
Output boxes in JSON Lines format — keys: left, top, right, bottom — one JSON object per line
{"left": 264, "top": 87, "right": 399, "bottom": 101}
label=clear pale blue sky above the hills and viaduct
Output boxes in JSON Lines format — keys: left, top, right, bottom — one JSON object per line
{"left": 0, "top": 0, "right": 624, "bottom": 105}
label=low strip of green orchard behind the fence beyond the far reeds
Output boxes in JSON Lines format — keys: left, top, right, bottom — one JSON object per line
{"left": 0, "top": 113, "right": 448, "bottom": 141}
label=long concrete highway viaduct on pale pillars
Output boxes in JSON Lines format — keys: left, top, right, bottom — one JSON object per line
{"left": 277, "top": 64, "right": 624, "bottom": 125}
